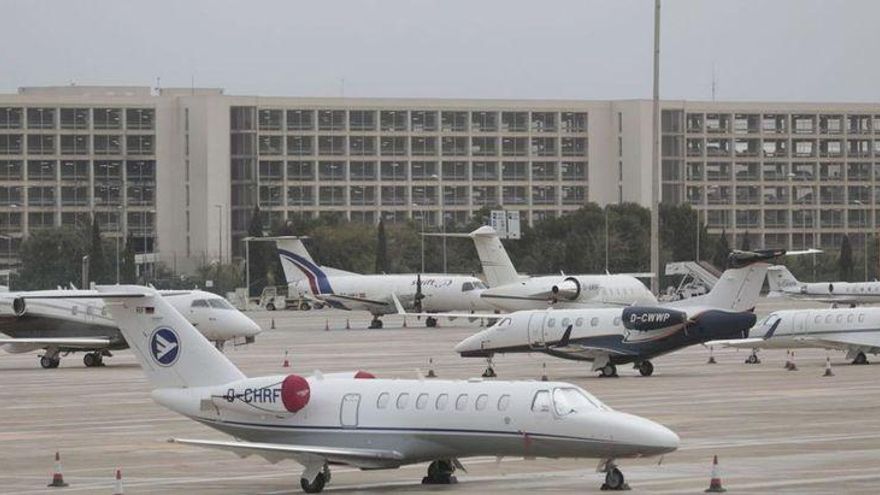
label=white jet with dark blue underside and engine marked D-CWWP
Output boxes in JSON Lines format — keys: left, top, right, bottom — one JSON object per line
{"left": 455, "top": 250, "right": 785, "bottom": 376}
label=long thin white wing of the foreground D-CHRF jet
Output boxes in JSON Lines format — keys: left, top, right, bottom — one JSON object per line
{"left": 168, "top": 438, "right": 403, "bottom": 468}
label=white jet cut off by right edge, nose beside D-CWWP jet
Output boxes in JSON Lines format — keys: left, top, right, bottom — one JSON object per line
{"left": 706, "top": 308, "right": 880, "bottom": 364}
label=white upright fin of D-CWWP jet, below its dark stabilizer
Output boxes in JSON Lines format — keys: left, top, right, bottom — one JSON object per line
{"left": 673, "top": 262, "right": 769, "bottom": 311}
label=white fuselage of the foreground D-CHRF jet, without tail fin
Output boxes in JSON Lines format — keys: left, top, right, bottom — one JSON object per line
{"left": 153, "top": 376, "right": 678, "bottom": 468}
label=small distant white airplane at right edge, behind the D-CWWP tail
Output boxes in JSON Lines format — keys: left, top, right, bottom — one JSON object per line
{"left": 767, "top": 265, "right": 880, "bottom": 305}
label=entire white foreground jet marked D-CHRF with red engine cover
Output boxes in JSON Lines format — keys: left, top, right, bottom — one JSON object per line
{"left": 77, "top": 286, "right": 679, "bottom": 493}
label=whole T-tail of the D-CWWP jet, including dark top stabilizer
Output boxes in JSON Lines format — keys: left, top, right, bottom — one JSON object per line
{"left": 672, "top": 250, "right": 785, "bottom": 311}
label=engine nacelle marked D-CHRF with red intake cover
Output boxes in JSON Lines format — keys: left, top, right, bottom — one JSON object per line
{"left": 211, "top": 375, "right": 311, "bottom": 415}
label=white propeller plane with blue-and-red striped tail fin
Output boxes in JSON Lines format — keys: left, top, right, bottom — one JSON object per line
{"left": 276, "top": 237, "right": 493, "bottom": 328}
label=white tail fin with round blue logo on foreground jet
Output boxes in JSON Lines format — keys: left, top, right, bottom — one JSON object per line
{"left": 96, "top": 285, "right": 245, "bottom": 388}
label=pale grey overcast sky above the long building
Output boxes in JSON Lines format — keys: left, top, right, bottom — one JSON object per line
{"left": 0, "top": 0, "right": 880, "bottom": 101}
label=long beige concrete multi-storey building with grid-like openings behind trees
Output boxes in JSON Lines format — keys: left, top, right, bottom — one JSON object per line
{"left": 0, "top": 86, "right": 880, "bottom": 270}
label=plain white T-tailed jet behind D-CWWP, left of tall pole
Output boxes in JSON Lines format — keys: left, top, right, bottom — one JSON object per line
{"left": 426, "top": 226, "right": 657, "bottom": 312}
